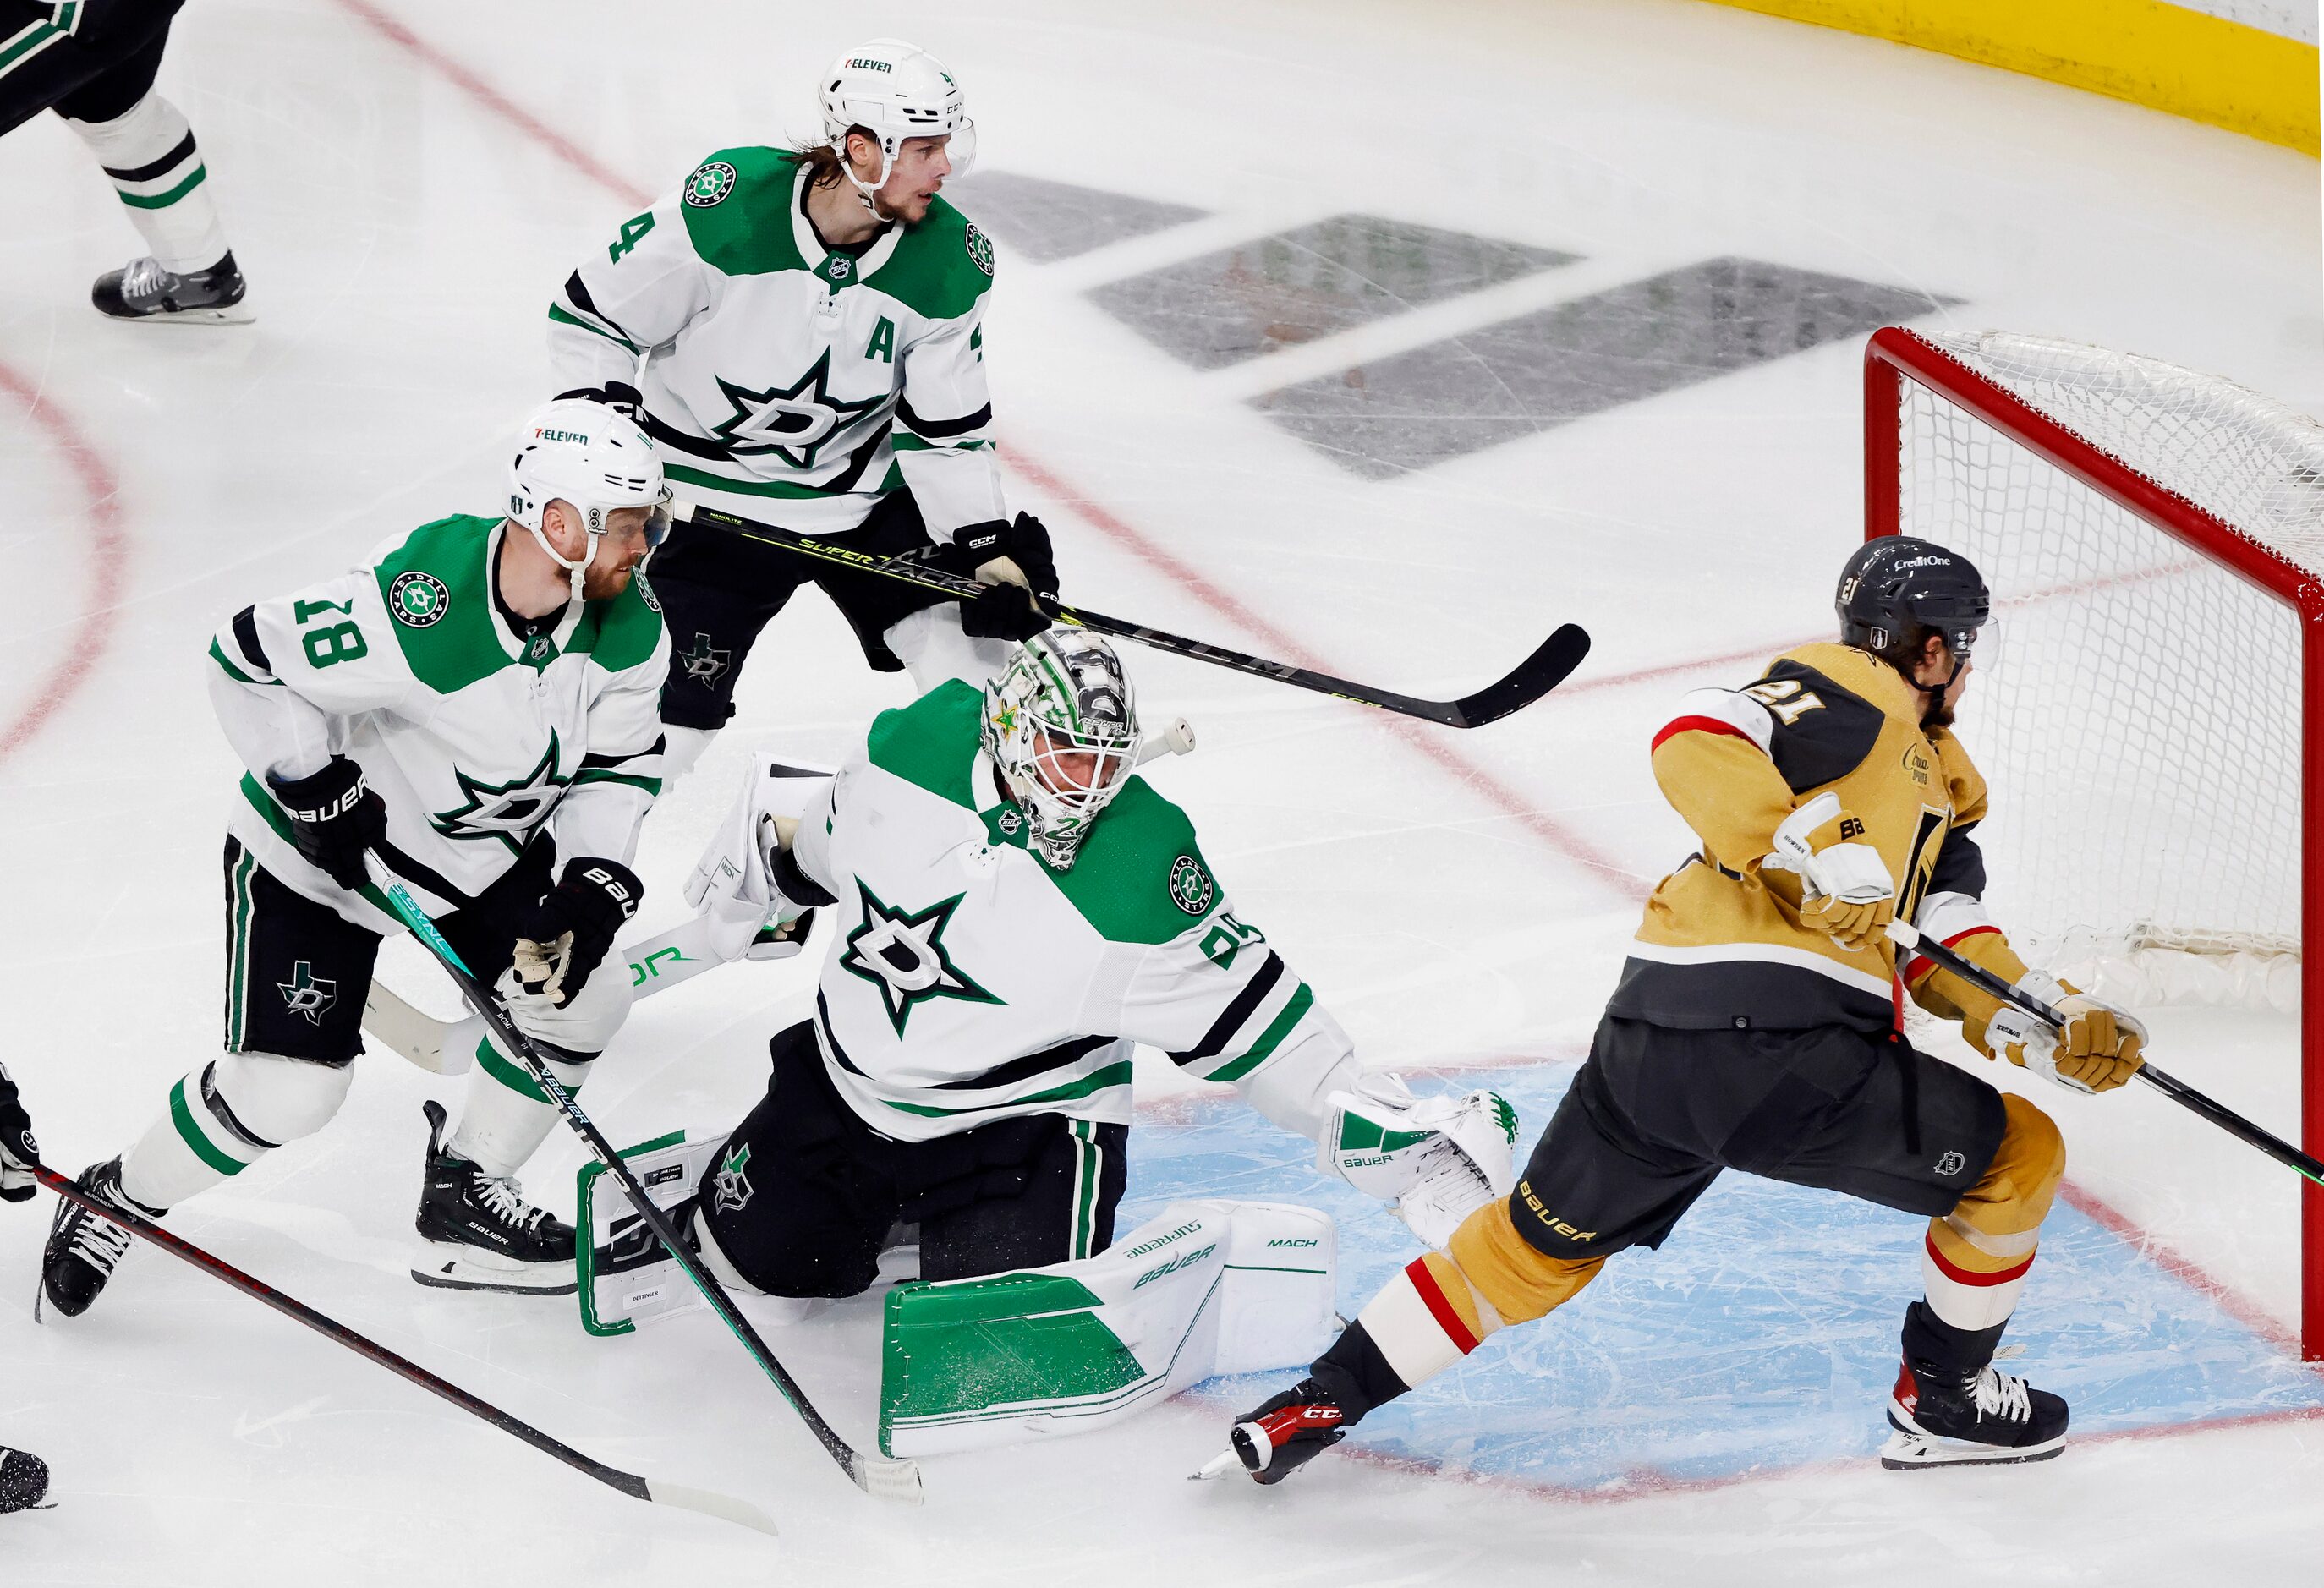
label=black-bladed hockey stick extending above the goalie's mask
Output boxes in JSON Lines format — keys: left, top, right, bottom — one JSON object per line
{"left": 671, "top": 502, "right": 1590, "bottom": 728}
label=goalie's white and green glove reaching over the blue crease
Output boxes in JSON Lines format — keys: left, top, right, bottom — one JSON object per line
{"left": 1315, "top": 1074, "right": 1517, "bottom": 1249}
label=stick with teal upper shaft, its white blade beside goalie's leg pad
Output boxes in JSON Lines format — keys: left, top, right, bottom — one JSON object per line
{"left": 370, "top": 856, "right": 920, "bottom": 1504}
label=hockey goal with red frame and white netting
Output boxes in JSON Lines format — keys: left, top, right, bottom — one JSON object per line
{"left": 1864, "top": 326, "right": 2324, "bottom": 1361}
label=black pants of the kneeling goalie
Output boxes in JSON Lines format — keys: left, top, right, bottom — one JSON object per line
{"left": 702, "top": 1021, "right": 1130, "bottom": 1297}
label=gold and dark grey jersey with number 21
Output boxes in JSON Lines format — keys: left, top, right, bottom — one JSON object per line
{"left": 1606, "top": 644, "right": 2025, "bottom": 1039}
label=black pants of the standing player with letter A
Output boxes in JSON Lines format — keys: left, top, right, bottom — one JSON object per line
{"left": 649, "top": 488, "right": 944, "bottom": 728}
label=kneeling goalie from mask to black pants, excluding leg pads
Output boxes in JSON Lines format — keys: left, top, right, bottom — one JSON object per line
{"left": 608, "top": 630, "right": 1513, "bottom": 1297}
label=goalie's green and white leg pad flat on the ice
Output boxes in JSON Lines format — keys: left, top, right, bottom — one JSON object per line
{"left": 879, "top": 1200, "right": 1336, "bottom": 1455}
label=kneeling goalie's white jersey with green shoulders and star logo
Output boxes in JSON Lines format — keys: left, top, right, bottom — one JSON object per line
{"left": 795, "top": 682, "right": 1355, "bottom": 1142}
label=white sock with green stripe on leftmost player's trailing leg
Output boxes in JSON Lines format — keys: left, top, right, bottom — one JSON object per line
{"left": 121, "top": 1054, "right": 355, "bottom": 1209}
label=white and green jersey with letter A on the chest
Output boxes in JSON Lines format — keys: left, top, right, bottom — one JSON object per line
{"left": 549, "top": 149, "right": 1006, "bottom": 544}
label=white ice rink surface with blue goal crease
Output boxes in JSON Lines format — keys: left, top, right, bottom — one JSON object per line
{"left": 0, "top": 0, "right": 2324, "bottom": 1588}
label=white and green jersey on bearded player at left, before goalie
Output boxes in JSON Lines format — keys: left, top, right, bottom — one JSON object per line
{"left": 209, "top": 518, "right": 669, "bottom": 933}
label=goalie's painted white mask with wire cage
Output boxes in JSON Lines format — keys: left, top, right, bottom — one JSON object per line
{"left": 983, "top": 627, "right": 1139, "bottom": 872}
